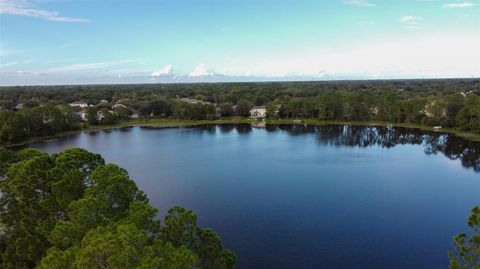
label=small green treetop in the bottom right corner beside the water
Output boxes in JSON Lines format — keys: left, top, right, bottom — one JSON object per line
{"left": 448, "top": 206, "right": 480, "bottom": 269}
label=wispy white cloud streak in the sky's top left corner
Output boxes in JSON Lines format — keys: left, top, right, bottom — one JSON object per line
{"left": 0, "top": 0, "right": 89, "bottom": 22}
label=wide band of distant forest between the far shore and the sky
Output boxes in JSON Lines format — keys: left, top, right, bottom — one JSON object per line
{"left": 0, "top": 79, "right": 480, "bottom": 144}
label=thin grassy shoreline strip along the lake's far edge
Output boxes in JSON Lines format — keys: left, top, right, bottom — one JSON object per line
{"left": 4, "top": 118, "right": 480, "bottom": 148}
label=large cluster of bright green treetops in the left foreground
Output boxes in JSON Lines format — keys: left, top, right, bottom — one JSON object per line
{"left": 0, "top": 148, "right": 236, "bottom": 269}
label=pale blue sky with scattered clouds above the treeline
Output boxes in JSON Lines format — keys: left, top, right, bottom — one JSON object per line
{"left": 0, "top": 0, "right": 480, "bottom": 85}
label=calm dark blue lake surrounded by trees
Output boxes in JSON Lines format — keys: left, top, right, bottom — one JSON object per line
{"left": 32, "top": 125, "right": 480, "bottom": 269}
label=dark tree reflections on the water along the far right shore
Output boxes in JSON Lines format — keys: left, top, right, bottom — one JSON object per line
{"left": 188, "top": 124, "right": 480, "bottom": 172}
